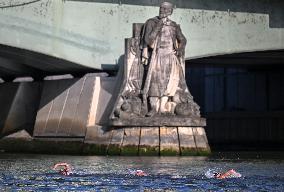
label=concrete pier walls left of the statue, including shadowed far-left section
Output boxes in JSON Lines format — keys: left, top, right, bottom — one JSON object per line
{"left": 0, "top": 73, "right": 120, "bottom": 138}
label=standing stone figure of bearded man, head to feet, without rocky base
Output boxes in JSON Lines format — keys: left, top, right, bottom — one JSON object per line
{"left": 142, "top": 2, "right": 189, "bottom": 116}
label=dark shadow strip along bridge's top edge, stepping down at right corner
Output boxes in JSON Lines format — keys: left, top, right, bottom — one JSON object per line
{"left": 66, "top": 0, "right": 284, "bottom": 28}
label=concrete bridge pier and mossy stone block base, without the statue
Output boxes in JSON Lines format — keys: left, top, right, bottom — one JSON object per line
{"left": 0, "top": 71, "right": 210, "bottom": 156}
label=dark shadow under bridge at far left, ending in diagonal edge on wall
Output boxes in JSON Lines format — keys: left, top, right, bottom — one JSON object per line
{"left": 0, "top": 44, "right": 98, "bottom": 137}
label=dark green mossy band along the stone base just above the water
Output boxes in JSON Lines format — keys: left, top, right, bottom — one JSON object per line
{"left": 0, "top": 138, "right": 211, "bottom": 156}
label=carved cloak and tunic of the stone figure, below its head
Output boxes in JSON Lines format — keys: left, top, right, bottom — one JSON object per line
{"left": 143, "top": 17, "right": 186, "bottom": 97}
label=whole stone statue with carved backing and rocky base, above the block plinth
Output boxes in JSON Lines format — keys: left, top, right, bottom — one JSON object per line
{"left": 111, "top": 2, "right": 203, "bottom": 126}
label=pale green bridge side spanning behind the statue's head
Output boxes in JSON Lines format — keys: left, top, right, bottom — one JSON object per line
{"left": 0, "top": 0, "right": 284, "bottom": 69}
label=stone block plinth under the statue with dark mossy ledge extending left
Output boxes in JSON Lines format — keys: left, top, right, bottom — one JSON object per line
{"left": 0, "top": 127, "right": 211, "bottom": 156}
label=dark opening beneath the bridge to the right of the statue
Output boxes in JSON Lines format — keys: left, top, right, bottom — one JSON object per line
{"left": 186, "top": 50, "right": 284, "bottom": 150}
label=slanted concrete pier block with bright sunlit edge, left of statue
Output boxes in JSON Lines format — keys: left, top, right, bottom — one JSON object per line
{"left": 33, "top": 73, "right": 119, "bottom": 138}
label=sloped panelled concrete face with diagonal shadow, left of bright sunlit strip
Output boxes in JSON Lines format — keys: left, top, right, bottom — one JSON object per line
{"left": 33, "top": 75, "right": 95, "bottom": 137}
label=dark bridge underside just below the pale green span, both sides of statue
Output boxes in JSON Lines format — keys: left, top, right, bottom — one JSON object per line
{"left": 0, "top": 44, "right": 284, "bottom": 82}
